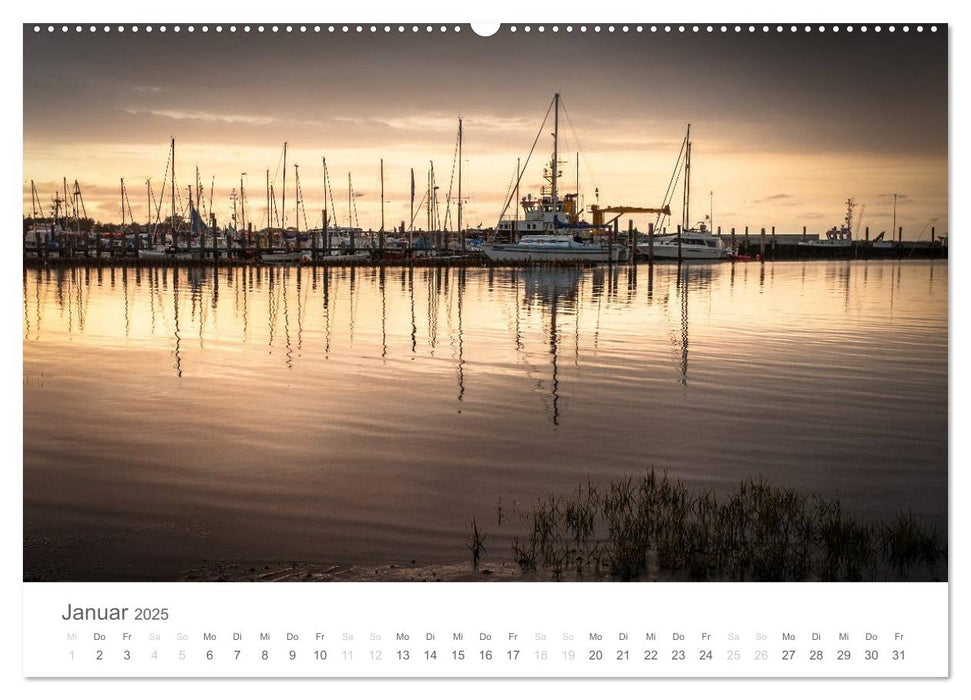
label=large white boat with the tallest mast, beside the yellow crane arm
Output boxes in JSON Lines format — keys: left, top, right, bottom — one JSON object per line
{"left": 482, "top": 93, "right": 626, "bottom": 262}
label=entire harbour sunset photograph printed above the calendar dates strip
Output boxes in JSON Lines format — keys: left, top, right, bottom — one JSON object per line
{"left": 24, "top": 22, "right": 949, "bottom": 592}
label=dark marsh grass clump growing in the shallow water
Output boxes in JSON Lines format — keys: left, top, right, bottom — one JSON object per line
{"left": 480, "top": 470, "right": 947, "bottom": 581}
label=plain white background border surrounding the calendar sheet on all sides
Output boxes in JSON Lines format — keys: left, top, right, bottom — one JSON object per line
{"left": 0, "top": 0, "right": 971, "bottom": 700}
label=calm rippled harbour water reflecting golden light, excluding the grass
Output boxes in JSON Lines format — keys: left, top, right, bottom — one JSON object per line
{"left": 23, "top": 262, "right": 948, "bottom": 579}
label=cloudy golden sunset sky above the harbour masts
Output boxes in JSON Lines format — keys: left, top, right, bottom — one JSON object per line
{"left": 23, "top": 25, "right": 948, "bottom": 238}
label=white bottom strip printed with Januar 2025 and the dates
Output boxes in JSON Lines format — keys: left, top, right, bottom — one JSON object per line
{"left": 24, "top": 582, "right": 948, "bottom": 678}
